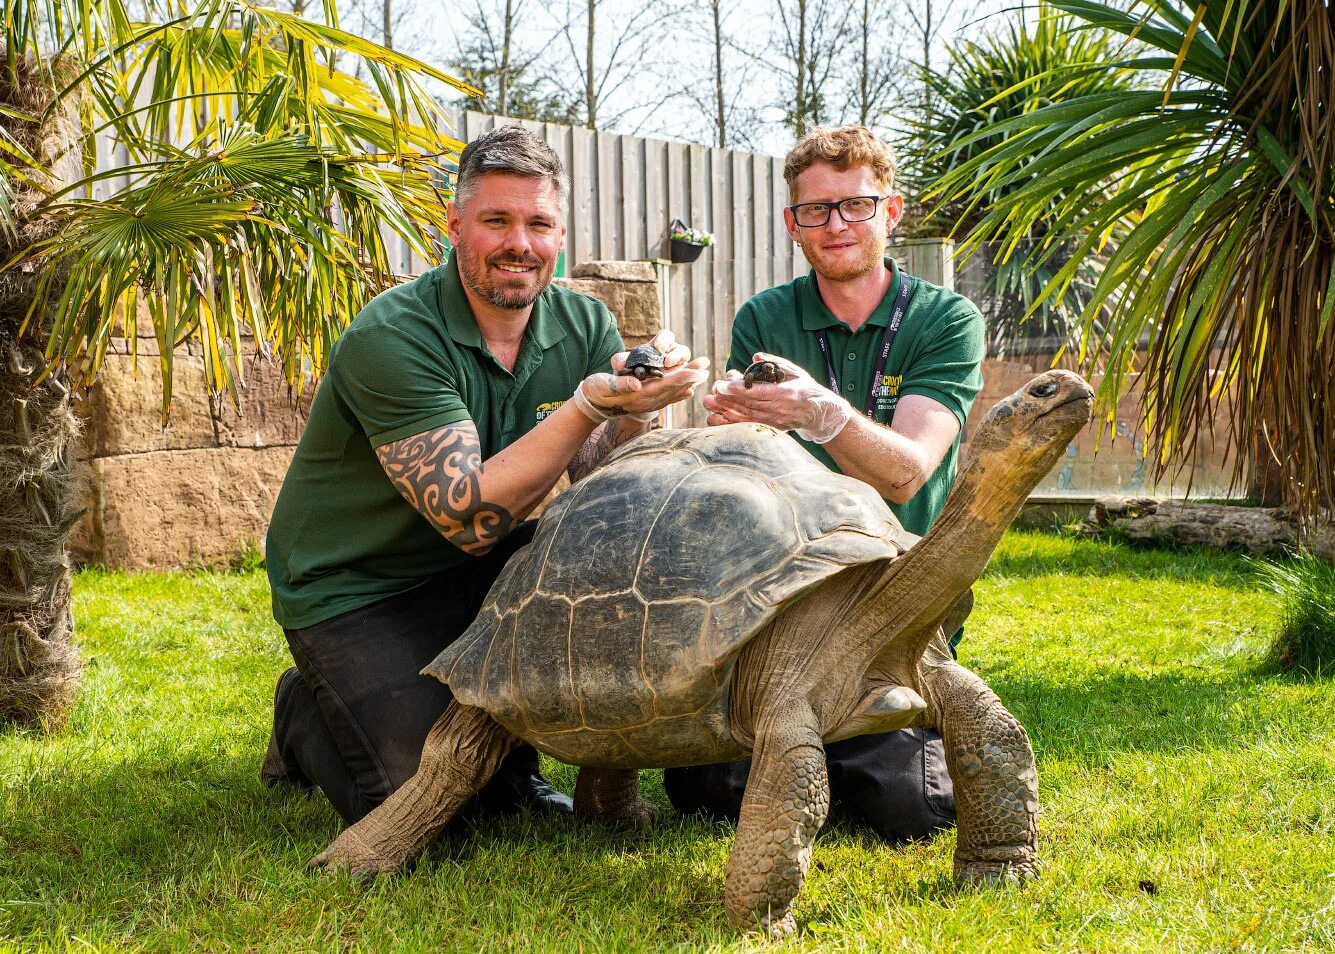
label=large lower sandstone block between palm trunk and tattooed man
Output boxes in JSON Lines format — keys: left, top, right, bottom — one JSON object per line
{"left": 72, "top": 447, "right": 294, "bottom": 570}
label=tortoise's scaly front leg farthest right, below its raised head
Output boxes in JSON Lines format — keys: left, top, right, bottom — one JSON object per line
{"left": 924, "top": 662, "right": 1039, "bottom": 883}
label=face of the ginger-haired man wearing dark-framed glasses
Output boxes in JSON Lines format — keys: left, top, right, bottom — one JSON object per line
{"left": 784, "top": 161, "right": 904, "bottom": 282}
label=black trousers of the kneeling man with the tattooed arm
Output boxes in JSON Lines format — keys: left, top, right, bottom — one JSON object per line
{"left": 274, "top": 522, "right": 538, "bottom": 823}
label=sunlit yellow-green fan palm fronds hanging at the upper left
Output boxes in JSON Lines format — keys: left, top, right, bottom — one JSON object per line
{"left": 0, "top": 0, "right": 475, "bottom": 415}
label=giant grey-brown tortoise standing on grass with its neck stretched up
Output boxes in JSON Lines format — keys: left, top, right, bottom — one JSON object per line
{"left": 311, "top": 371, "right": 1092, "bottom": 934}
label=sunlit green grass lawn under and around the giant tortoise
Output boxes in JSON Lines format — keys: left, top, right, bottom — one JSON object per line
{"left": 0, "top": 532, "right": 1335, "bottom": 951}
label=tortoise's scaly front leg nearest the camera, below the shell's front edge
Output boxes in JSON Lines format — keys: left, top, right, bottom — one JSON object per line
{"left": 726, "top": 699, "right": 830, "bottom": 937}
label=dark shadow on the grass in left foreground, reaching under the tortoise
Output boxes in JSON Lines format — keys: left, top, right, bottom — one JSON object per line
{"left": 0, "top": 753, "right": 730, "bottom": 937}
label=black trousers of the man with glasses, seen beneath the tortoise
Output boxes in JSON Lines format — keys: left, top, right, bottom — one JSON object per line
{"left": 663, "top": 729, "right": 955, "bottom": 843}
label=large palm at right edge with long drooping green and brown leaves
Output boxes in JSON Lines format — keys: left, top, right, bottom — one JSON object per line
{"left": 939, "top": 0, "right": 1335, "bottom": 522}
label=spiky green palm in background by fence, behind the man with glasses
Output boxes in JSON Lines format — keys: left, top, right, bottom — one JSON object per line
{"left": 905, "top": 7, "right": 1157, "bottom": 354}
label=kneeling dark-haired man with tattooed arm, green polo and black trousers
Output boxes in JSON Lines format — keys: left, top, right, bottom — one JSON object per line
{"left": 260, "top": 125, "right": 709, "bottom": 823}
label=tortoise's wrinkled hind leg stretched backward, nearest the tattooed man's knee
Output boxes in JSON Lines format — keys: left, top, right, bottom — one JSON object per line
{"left": 310, "top": 700, "right": 519, "bottom": 875}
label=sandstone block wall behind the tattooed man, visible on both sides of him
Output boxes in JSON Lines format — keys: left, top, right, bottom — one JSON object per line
{"left": 71, "top": 262, "right": 662, "bottom": 570}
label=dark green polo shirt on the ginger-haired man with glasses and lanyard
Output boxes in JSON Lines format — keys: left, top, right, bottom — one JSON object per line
{"left": 728, "top": 259, "right": 983, "bottom": 535}
